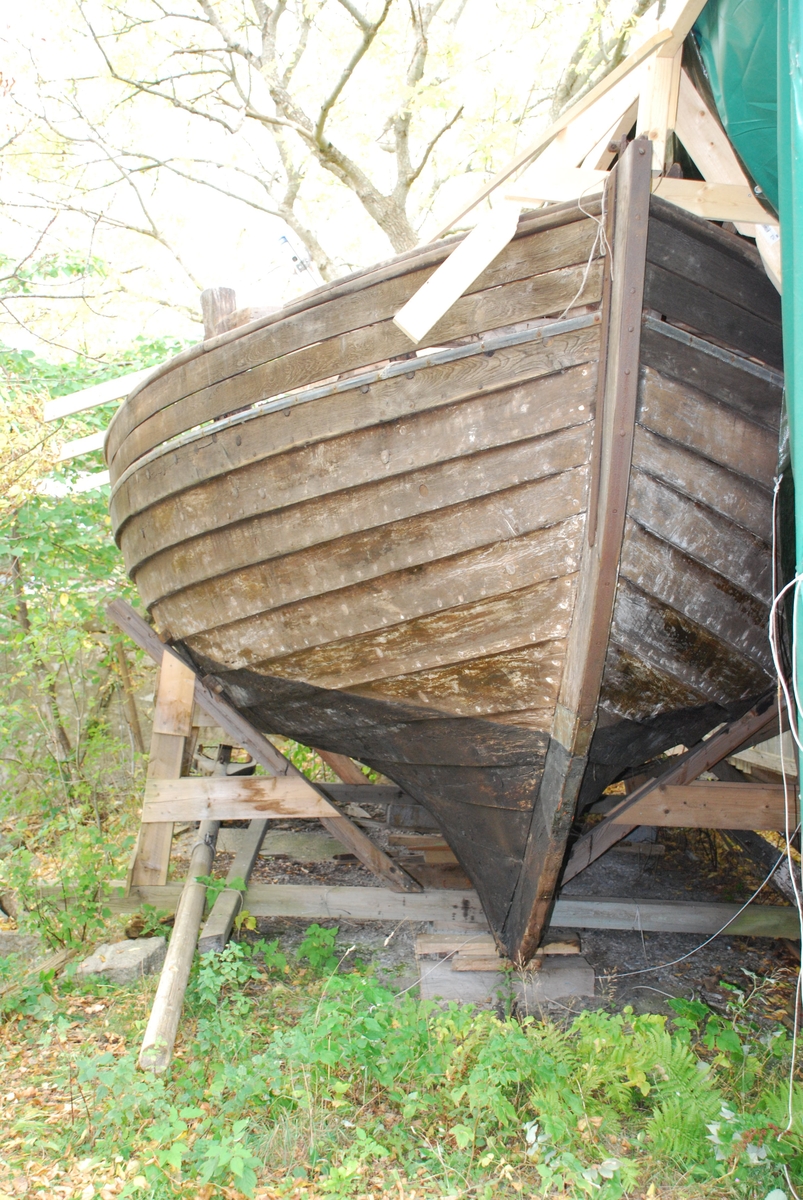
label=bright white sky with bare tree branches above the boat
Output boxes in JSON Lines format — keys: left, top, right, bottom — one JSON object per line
{"left": 0, "top": 0, "right": 658, "bottom": 358}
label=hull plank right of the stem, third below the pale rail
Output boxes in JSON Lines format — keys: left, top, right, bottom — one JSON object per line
{"left": 633, "top": 425, "right": 772, "bottom": 544}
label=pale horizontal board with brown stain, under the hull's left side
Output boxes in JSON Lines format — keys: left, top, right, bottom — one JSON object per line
{"left": 142, "top": 775, "right": 338, "bottom": 824}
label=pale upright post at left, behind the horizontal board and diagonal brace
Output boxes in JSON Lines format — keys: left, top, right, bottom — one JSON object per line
{"left": 127, "top": 643, "right": 194, "bottom": 888}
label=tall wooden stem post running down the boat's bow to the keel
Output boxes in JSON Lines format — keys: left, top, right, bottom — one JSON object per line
{"left": 502, "top": 138, "right": 652, "bottom": 962}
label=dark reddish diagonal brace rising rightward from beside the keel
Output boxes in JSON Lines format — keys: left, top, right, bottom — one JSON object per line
{"left": 561, "top": 695, "right": 777, "bottom": 884}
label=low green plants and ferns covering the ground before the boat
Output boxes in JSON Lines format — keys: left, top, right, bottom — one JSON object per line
{"left": 0, "top": 925, "right": 803, "bottom": 1200}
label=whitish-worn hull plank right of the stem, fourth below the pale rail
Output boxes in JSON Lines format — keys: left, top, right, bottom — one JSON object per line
{"left": 628, "top": 470, "right": 772, "bottom": 606}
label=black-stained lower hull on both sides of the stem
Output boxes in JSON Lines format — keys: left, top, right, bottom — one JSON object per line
{"left": 185, "top": 648, "right": 750, "bottom": 940}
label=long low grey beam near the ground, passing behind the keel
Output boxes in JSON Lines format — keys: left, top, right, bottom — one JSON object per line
{"left": 108, "top": 883, "right": 801, "bottom": 940}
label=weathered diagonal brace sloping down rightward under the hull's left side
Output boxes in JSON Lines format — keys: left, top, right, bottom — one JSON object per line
{"left": 107, "top": 600, "right": 421, "bottom": 892}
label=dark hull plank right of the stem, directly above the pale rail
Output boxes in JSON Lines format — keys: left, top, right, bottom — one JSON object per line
{"left": 645, "top": 263, "right": 784, "bottom": 367}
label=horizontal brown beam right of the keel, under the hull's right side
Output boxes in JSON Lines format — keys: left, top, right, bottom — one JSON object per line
{"left": 613, "top": 781, "right": 797, "bottom": 830}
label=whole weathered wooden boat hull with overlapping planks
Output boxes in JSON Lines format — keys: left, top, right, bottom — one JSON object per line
{"left": 107, "top": 143, "right": 781, "bottom": 958}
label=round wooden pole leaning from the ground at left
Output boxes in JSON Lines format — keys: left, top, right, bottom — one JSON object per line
{"left": 139, "top": 821, "right": 220, "bottom": 1075}
